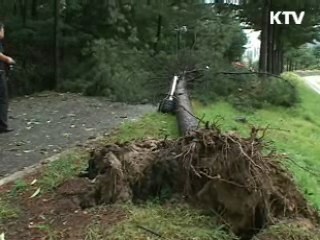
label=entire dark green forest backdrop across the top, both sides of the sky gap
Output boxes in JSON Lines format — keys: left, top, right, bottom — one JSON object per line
{"left": 0, "top": 0, "right": 320, "bottom": 107}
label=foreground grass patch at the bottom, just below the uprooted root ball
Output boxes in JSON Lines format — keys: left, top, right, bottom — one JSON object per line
{"left": 86, "top": 203, "right": 236, "bottom": 240}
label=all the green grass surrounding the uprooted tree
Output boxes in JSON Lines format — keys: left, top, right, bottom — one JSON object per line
{"left": 0, "top": 73, "right": 320, "bottom": 240}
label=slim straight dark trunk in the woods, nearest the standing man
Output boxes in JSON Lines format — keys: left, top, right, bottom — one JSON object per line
{"left": 54, "top": 0, "right": 60, "bottom": 88}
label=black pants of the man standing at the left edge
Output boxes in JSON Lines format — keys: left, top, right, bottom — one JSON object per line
{"left": 0, "top": 72, "right": 9, "bottom": 130}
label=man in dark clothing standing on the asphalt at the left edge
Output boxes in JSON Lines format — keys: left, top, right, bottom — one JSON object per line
{"left": 0, "top": 23, "right": 15, "bottom": 133}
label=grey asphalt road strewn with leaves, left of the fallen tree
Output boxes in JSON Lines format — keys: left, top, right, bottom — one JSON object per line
{"left": 0, "top": 93, "right": 155, "bottom": 178}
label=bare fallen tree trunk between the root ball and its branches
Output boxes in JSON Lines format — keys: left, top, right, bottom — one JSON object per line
{"left": 176, "top": 77, "right": 199, "bottom": 136}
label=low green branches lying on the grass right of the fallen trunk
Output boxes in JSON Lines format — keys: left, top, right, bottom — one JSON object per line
{"left": 194, "top": 70, "right": 299, "bottom": 111}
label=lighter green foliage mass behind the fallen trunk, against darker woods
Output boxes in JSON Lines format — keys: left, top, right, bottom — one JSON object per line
{"left": 63, "top": 4, "right": 246, "bottom": 102}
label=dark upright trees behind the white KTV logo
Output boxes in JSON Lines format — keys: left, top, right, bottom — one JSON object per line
{"left": 240, "top": 0, "right": 320, "bottom": 74}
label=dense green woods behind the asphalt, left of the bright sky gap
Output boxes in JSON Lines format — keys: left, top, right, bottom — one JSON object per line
{"left": 0, "top": 0, "right": 245, "bottom": 102}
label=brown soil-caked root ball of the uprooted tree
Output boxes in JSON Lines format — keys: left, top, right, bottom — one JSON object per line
{"left": 81, "top": 128, "right": 318, "bottom": 239}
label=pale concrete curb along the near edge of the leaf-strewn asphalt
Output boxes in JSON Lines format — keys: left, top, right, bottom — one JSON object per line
{"left": 0, "top": 149, "right": 72, "bottom": 187}
